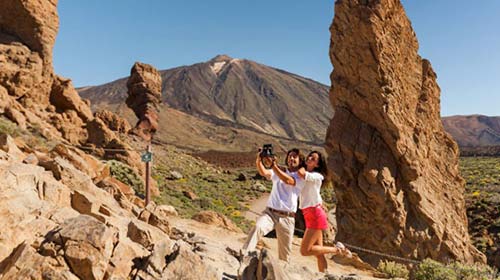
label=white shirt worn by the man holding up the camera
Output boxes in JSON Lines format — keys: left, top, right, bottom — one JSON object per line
{"left": 267, "top": 169, "right": 304, "bottom": 212}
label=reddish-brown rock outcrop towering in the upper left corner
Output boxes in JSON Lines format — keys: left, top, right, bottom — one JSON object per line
{"left": 0, "top": 0, "right": 92, "bottom": 144}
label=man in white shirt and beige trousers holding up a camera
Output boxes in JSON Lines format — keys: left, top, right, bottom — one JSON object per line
{"left": 243, "top": 149, "right": 304, "bottom": 262}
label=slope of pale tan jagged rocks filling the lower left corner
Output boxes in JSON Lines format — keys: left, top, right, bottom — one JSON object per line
{"left": 0, "top": 135, "right": 222, "bottom": 279}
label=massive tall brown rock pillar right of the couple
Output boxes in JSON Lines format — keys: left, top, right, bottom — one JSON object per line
{"left": 326, "top": 0, "right": 484, "bottom": 265}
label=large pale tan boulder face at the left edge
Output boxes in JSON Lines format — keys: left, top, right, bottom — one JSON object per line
{"left": 0, "top": 161, "right": 70, "bottom": 261}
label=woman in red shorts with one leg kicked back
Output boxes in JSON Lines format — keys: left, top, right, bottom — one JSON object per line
{"left": 297, "top": 151, "right": 352, "bottom": 272}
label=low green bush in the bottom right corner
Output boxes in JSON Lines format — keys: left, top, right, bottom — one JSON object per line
{"left": 414, "top": 259, "right": 500, "bottom": 280}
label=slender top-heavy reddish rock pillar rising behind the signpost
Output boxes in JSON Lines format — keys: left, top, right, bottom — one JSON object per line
{"left": 126, "top": 62, "right": 161, "bottom": 141}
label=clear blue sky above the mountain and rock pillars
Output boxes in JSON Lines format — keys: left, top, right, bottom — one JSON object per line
{"left": 54, "top": 0, "right": 500, "bottom": 116}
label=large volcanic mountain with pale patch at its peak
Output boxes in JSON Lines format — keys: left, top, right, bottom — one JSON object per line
{"left": 78, "top": 55, "right": 333, "bottom": 150}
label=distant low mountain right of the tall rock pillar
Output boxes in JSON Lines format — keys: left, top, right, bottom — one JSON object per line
{"left": 442, "top": 115, "right": 500, "bottom": 147}
